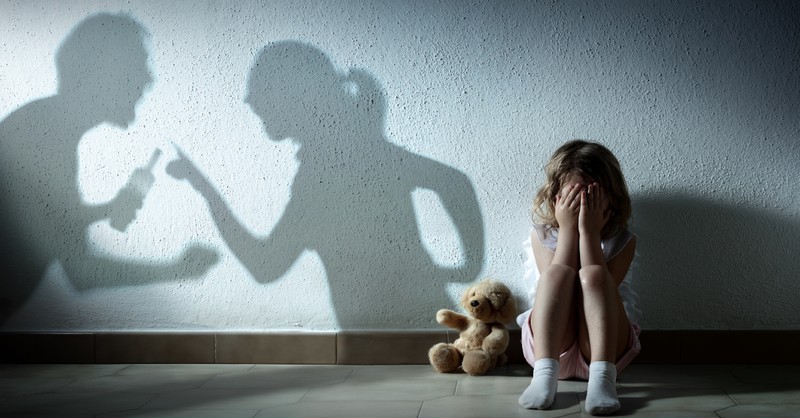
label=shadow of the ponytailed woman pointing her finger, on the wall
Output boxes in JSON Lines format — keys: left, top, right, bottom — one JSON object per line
{"left": 167, "top": 41, "right": 484, "bottom": 329}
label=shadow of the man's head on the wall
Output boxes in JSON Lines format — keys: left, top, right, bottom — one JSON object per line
{"left": 56, "top": 13, "right": 153, "bottom": 127}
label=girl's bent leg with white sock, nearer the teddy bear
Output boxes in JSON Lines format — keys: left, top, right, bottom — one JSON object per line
{"left": 519, "top": 264, "right": 578, "bottom": 409}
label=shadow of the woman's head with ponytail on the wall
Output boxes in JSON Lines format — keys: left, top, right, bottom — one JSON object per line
{"left": 245, "top": 41, "right": 386, "bottom": 145}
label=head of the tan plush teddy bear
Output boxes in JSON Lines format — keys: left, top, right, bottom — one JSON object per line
{"left": 461, "top": 279, "right": 517, "bottom": 324}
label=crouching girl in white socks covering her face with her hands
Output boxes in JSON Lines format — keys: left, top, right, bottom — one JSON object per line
{"left": 517, "top": 140, "right": 640, "bottom": 415}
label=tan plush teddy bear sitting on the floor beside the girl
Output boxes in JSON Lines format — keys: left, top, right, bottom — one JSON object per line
{"left": 428, "top": 279, "right": 517, "bottom": 376}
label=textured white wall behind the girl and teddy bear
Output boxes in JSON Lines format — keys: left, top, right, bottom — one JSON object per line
{"left": 0, "top": 0, "right": 800, "bottom": 330}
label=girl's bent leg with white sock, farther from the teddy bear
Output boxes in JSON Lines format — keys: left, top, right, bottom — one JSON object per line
{"left": 578, "top": 265, "right": 630, "bottom": 415}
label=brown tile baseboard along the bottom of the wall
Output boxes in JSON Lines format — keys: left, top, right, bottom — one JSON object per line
{"left": 0, "top": 330, "right": 800, "bottom": 365}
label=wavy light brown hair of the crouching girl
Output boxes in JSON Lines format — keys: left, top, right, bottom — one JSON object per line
{"left": 533, "top": 140, "right": 631, "bottom": 238}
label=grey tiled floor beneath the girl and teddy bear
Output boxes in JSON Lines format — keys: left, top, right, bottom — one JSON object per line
{"left": 0, "top": 364, "right": 800, "bottom": 418}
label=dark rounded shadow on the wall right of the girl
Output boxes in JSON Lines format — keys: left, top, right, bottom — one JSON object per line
{"left": 633, "top": 192, "right": 800, "bottom": 329}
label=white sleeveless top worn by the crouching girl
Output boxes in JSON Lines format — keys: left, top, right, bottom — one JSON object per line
{"left": 517, "top": 225, "right": 642, "bottom": 327}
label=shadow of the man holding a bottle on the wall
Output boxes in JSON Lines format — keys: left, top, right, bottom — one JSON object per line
{"left": 0, "top": 14, "right": 217, "bottom": 324}
